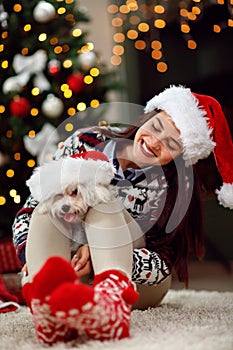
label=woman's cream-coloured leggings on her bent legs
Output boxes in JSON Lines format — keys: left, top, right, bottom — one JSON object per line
{"left": 26, "top": 200, "right": 171, "bottom": 309}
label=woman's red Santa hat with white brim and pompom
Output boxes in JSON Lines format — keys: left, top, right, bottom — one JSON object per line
{"left": 145, "top": 86, "right": 233, "bottom": 209}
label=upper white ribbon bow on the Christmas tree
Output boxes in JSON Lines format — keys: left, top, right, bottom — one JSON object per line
{"left": 3, "top": 50, "right": 50, "bottom": 94}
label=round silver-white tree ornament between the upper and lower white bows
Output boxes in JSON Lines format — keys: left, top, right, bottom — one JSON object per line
{"left": 41, "top": 94, "right": 64, "bottom": 119}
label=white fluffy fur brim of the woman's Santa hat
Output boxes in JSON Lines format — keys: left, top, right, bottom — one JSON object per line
{"left": 145, "top": 86, "right": 215, "bottom": 166}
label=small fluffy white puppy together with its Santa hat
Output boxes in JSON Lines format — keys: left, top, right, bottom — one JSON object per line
{"left": 26, "top": 151, "right": 115, "bottom": 223}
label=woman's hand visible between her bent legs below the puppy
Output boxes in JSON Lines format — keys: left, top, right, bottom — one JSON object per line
{"left": 71, "top": 245, "right": 92, "bottom": 277}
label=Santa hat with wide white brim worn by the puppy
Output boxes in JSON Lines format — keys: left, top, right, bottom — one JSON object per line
{"left": 26, "top": 151, "right": 115, "bottom": 202}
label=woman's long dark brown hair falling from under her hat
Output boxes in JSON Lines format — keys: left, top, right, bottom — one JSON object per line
{"left": 94, "top": 110, "right": 204, "bottom": 286}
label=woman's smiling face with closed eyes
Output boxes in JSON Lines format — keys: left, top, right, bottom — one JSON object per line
{"left": 133, "top": 111, "right": 183, "bottom": 167}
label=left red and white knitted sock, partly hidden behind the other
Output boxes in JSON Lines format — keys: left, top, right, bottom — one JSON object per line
{"left": 22, "top": 257, "right": 77, "bottom": 345}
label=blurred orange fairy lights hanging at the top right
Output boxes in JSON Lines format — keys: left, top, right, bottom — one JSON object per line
{"left": 108, "top": 0, "right": 233, "bottom": 73}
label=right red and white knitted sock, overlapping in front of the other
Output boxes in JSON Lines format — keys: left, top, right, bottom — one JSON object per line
{"left": 49, "top": 270, "right": 138, "bottom": 340}
